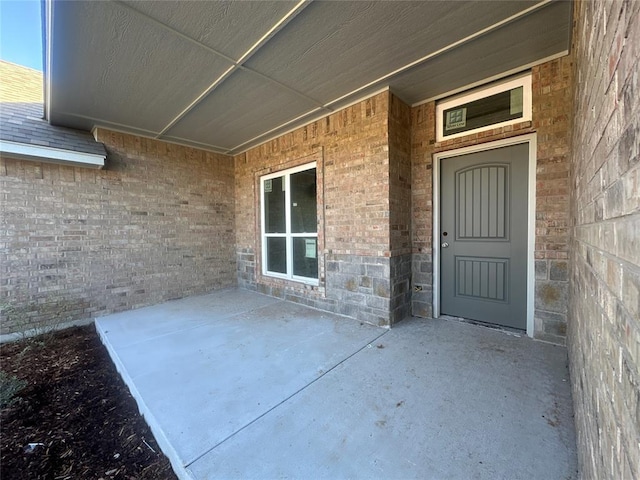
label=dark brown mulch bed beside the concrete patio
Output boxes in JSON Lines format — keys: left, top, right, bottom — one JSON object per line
{"left": 0, "top": 325, "right": 176, "bottom": 480}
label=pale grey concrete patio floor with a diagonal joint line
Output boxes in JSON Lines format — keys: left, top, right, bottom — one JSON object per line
{"left": 96, "top": 290, "right": 578, "bottom": 480}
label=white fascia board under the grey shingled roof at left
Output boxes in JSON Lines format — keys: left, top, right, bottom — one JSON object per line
{"left": 0, "top": 140, "right": 106, "bottom": 168}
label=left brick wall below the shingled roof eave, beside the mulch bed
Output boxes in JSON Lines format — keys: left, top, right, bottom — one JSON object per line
{"left": 0, "top": 130, "right": 236, "bottom": 333}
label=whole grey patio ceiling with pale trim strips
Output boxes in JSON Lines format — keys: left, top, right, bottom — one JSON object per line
{"left": 46, "top": 0, "right": 571, "bottom": 154}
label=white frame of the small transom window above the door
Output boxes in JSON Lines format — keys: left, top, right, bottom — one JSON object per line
{"left": 436, "top": 72, "right": 532, "bottom": 142}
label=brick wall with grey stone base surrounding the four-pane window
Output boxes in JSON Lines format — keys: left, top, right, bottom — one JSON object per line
{"left": 235, "top": 92, "right": 410, "bottom": 325}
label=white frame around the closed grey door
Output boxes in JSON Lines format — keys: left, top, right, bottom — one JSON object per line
{"left": 432, "top": 133, "right": 537, "bottom": 337}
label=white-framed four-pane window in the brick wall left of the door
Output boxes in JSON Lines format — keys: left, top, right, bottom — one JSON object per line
{"left": 260, "top": 162, "right": 318, "bottom": 285}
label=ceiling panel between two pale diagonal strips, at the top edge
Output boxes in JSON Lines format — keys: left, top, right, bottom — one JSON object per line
{"left": 240, "top": 1, "right": 534, "bottom": 104}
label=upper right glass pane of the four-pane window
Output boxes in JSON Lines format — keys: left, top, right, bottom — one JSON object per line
{"left": 290, "top": 168, "right": 318, "bottom": 233}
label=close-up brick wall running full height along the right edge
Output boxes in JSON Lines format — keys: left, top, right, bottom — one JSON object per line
{"left": 567, "top": 0, "right": 640, "bottom": 479}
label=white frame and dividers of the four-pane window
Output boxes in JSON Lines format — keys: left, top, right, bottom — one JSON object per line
{"left": 260, "top": 162, "right": 319, "bottom": 285}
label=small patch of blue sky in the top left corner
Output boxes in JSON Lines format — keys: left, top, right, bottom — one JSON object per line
{"left": 0, "top": 0, "right": 42, "bottom": 71}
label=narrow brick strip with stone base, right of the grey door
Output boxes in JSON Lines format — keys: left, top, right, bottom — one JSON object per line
{"left": 532, "top": 56, "right": 573, "bottom": 343}
